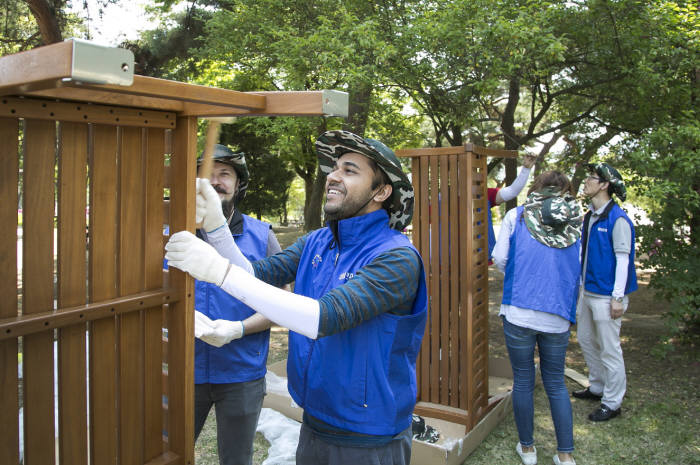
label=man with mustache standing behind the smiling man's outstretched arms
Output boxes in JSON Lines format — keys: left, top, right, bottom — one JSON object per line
{"left": 194, "top": 144, "right": 281, "bottom": 465}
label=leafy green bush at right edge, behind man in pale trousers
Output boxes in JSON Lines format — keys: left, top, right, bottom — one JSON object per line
{"left": 626, "top": 111, "right": 700, "bottom": 343}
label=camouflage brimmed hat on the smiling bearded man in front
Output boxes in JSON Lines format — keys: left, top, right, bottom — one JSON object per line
{"left": 316, "top": 130, "right": 414, "bottom": 231}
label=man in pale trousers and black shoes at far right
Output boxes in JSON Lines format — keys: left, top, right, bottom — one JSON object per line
{"left": 572, "top": 163, "right": 637, "bottom": 421}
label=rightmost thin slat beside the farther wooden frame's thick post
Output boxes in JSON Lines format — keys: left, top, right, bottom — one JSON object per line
{"left": 448, "top": 155, "right": 464, "bottom": 407}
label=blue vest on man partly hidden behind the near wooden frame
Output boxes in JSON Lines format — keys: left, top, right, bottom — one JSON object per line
{"left": 194, "top": 215, "right": 270, "bottom": 384}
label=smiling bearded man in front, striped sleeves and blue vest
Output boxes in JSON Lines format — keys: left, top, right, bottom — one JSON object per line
{"left": 166, "top": 131, "right": 427, "bottom": 465}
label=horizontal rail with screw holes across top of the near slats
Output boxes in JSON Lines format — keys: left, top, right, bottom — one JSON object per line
{"left": 0, "top": 97, "right": 176, "bottom": 129}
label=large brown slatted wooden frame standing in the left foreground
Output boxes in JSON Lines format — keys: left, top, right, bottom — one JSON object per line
{"left": 0, "top": 40, "right": 348, "bottom": 465}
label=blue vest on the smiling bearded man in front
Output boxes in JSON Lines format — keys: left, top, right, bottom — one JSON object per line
{"left": 287, "top": 210, "right": 428, "bottom": 435}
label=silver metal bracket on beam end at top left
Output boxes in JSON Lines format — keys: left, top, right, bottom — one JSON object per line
{"left": 69, "top": 39, "right": 134, "bottom": 86}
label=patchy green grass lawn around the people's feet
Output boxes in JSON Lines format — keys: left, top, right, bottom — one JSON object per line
{"left": 195, "top": 226, "right": 700, "bottom": 465}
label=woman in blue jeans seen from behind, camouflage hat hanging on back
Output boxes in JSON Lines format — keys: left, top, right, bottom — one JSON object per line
{"left": 493, "top": 171, "right": 582, "bottom": 465}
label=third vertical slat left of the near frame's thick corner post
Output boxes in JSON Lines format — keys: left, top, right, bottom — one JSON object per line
{"left": 89, "top": 125, "right": 119, "bottom": 465}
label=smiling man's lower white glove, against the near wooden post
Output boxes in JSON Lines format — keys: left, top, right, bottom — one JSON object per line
{"left": 165, "top": 231, "right": 229, "bottom": 286}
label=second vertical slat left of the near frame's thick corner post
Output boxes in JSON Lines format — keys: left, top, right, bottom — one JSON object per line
{"left": 119, "top": 128, "right": 144, "bottom": 463}
